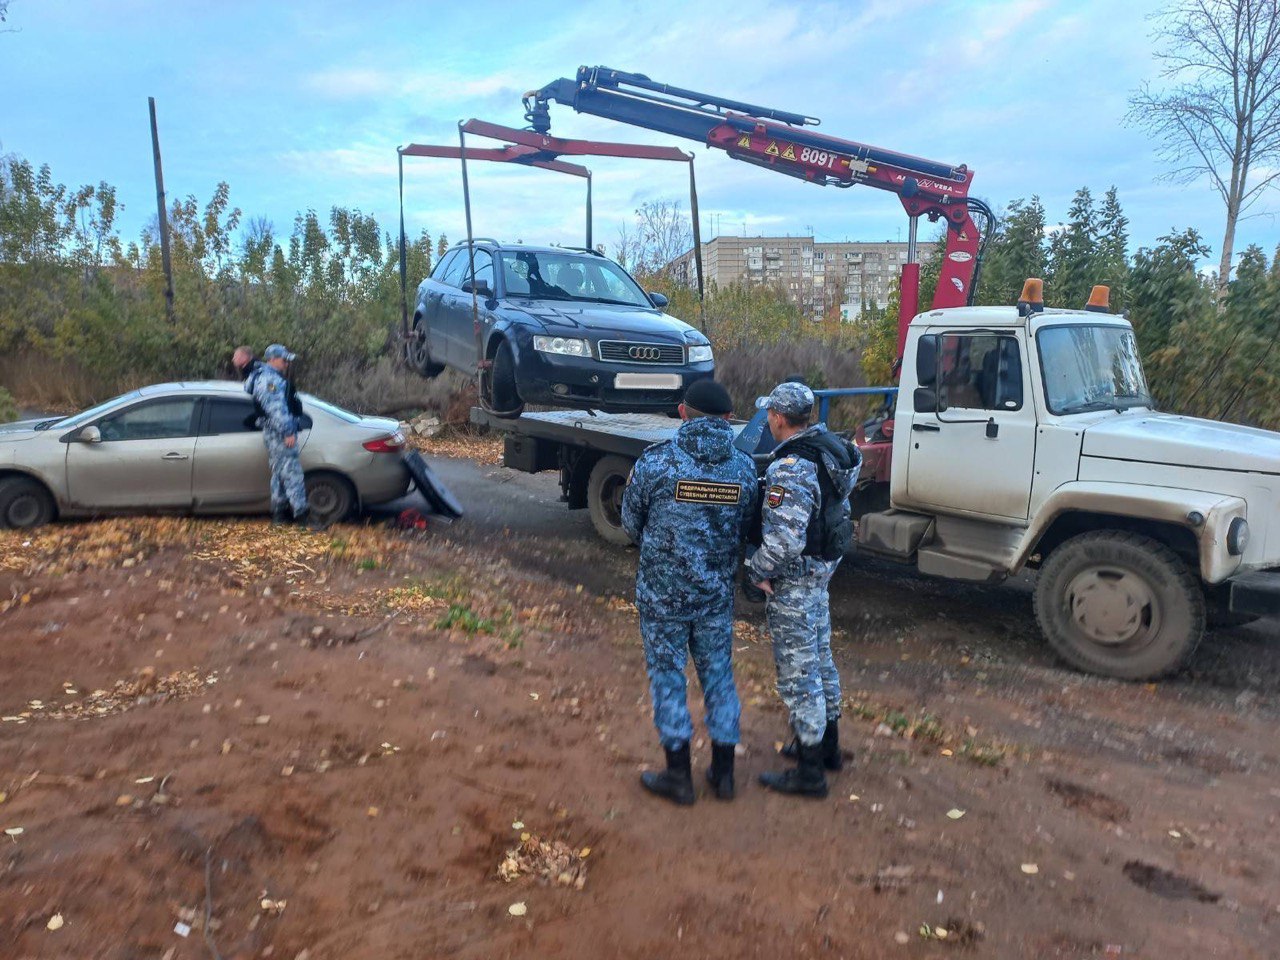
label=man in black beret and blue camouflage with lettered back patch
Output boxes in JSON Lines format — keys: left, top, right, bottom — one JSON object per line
{"left": 622, "top": 380, "right": 756, "bottom": 804}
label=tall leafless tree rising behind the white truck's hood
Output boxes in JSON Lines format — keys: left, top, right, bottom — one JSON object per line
{"left": 1128, "top": 0, "right": 1280, "bottom": 288}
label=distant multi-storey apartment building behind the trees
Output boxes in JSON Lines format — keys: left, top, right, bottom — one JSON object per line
{"left": 671, "top": 237, "right": 934, "bottom": 320}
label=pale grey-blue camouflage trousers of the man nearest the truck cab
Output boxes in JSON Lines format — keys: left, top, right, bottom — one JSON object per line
{"left": 765, "top": 558, "right": 840, "bottom": 745}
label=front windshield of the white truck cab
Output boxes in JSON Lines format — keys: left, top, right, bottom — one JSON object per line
{"left": 1036, "top": 325, "right": 1151, "bottom": 415}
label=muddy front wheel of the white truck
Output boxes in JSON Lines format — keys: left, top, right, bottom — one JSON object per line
{"left": 1034, "top": 530, "right": 1204, "bottom": 680}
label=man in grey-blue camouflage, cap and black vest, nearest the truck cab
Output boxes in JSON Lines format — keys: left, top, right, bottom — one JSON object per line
{"left": 746, "top": 383, "right": 861, "bottom": 797}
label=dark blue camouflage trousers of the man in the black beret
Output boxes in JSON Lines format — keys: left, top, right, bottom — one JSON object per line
{"left": 640, "top": 609, "right": 742, "bottom": 750}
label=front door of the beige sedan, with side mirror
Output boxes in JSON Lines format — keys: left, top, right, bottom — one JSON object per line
{"left": 67, "top": 397, "right": 198, "bottom": 511}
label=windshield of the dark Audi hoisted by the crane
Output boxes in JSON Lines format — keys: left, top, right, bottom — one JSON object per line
{"left": 499, "top": 250, "right": 652, "bottom": 307}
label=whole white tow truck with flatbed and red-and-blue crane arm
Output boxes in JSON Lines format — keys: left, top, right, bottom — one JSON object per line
{"left": 474, "top": 67, "right": 1280, "bottom": 680}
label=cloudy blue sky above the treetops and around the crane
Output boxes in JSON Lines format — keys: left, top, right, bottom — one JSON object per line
{"left": 0, "top": 0, "right": 1280, "bottom": 271}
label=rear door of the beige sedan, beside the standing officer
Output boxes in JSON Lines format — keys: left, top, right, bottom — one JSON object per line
{"left": 192, "top": 397, "right": 271, "bottom": 513}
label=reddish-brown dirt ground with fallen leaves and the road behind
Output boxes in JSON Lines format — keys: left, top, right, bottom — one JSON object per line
{"left": 0, "top": 448, "right": 1280, "bottom": 960}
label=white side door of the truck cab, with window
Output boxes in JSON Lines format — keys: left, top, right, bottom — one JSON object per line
{"left": 899, "top": 330, "right": 1036, "bottom": 521}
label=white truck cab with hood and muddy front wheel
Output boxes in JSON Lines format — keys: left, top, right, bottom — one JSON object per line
{"left": 858, "top": 289, "right": 1280, "bottom": 680}
